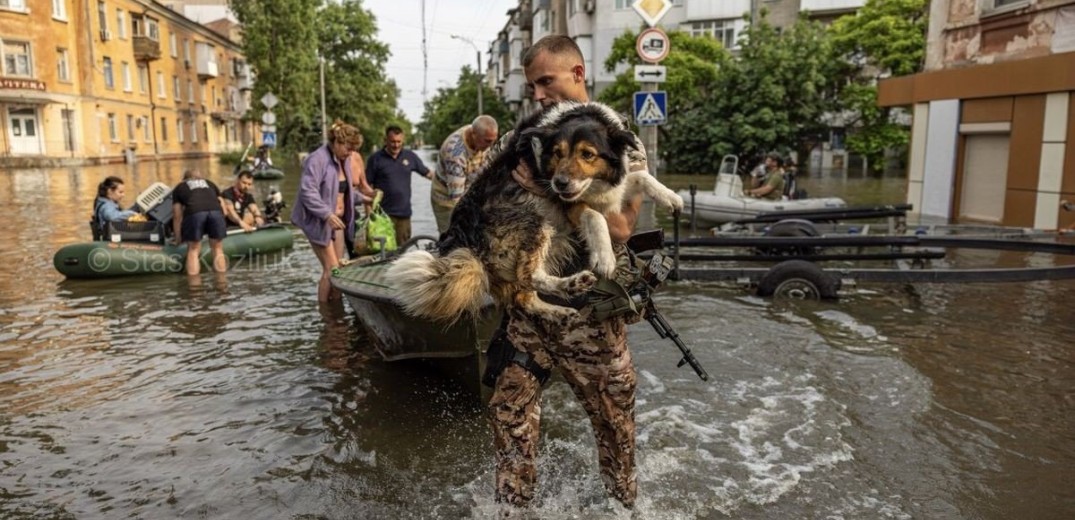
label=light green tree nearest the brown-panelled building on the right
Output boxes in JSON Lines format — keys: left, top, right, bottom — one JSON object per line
{"left": 830, "top": 0, "right": 929, "bottom": 170}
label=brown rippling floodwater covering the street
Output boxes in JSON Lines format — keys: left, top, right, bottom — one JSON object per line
{"left": 0, "top": 156, "right": 1075, "bottom": 519}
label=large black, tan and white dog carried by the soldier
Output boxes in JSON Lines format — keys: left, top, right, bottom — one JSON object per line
{"left": 388, "top": 102, "right": 683, "bottom": 322}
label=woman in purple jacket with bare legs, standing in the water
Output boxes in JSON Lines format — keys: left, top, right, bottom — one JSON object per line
{"left": 291, "top": 119, "right": 362, "bottom": 302}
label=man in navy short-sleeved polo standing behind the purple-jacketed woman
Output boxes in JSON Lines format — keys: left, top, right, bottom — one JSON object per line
{"left": 366, "top": 127, "right": 433, "bottom": 244}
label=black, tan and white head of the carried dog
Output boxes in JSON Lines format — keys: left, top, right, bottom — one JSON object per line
{"left": 528, "top": 116, "right": 635, "bottom": 202}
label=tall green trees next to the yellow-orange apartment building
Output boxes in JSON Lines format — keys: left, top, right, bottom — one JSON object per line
{"left": 230, "top": 0, "right": 410, "bottom": 149}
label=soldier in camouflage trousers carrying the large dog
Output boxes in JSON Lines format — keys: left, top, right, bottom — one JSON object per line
{"left": 486, "top": 35, "right": 647, "bottom": 507}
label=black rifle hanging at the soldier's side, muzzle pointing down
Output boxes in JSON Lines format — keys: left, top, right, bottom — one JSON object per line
{"left": 627, "top": 230, "right": 710, "bottom": 381}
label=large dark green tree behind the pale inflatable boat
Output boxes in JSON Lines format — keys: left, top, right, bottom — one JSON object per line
{"left": 661, "top": 18, "right": 836, "bottom": 172}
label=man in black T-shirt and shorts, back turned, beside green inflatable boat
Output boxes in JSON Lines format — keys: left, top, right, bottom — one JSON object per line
{"left": 172, "top": 170, "right": 228, "bottom": 275}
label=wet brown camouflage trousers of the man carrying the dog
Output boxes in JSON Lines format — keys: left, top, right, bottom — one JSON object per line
{"left": 489, "top": 309, "right": 637, "bottom": 507}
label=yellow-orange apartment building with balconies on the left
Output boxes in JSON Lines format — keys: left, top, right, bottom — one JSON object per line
{"left": 0, "top": 0, "right": 253, "bottom": 167}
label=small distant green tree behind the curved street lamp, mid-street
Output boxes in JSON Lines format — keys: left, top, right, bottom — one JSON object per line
{"left": 418, "top": 66, "right": 515, "bottom": 146}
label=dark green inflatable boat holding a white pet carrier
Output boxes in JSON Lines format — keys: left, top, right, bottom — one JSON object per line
{"left": 53, "top": 225, "right": 295, "bottom": 278}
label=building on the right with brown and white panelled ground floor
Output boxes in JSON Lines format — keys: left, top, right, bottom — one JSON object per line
{"left": 878, "top": 0, "right": 1075, "bottom": 229}
